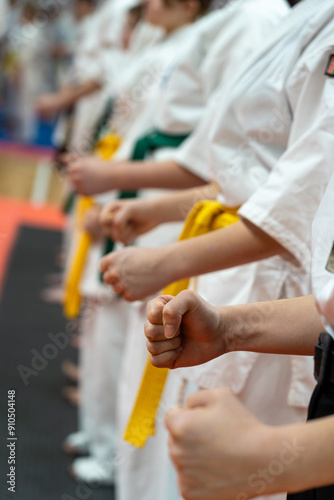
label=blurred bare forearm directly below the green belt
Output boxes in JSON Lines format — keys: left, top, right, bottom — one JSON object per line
{"left": 107, "top": 161, "right": 206, "bottom": 191}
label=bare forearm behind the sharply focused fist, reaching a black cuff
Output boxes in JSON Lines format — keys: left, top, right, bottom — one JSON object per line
{"left": 223, "top": 295, "right": 323, "bottom": 356}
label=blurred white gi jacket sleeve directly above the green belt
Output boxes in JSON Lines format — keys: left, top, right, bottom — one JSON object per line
{"left": 154, "top": 0, "right": 289, "bottom": 134}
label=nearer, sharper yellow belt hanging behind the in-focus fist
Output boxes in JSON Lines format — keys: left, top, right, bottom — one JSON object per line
{"left": 124, "top": 200, "right": 239, "bottom": 447}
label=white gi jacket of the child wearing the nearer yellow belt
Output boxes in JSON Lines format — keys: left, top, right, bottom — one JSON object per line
{"left": 181, "top": 0, "right": 334, "bottom": 407}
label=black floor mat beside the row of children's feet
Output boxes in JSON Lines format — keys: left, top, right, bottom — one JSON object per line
{"left": 0, "top": 227, "right": 114, "bottom": 500}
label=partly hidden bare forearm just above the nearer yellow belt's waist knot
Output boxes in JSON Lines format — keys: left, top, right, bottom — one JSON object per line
{"left": 147, "top": 184, "right": 217, "bottom": 223}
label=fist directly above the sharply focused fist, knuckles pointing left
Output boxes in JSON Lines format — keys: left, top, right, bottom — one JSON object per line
{"left": 100, "top": 247, "right": 173, "bottom": 302}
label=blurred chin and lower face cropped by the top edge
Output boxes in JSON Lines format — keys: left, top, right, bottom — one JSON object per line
{"left": 144, "top": 0, "right": 196, "bottom": 31}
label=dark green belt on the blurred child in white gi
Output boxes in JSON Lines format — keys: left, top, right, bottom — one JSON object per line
{"left": 101, "top": 130, "right": 189, "bottom": 279}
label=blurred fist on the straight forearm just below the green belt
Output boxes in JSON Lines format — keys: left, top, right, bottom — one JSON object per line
{"left": 66, "top": 155, "right": 110, "bottom": 196}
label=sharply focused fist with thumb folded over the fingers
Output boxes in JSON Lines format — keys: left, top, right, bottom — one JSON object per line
{"left": 145, "top": 290, "right": 227, "bottom": 369}
